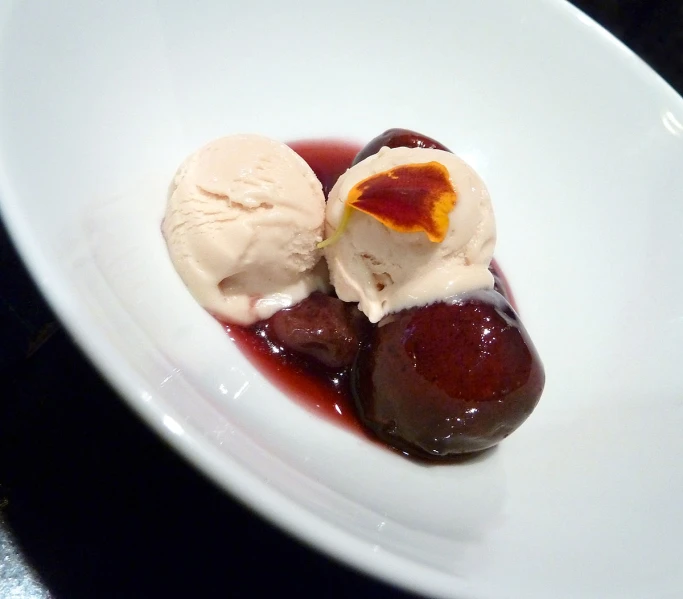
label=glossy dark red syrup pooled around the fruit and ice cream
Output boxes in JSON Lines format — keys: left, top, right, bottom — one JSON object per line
{"left": 225, "top": 140, "right": 514, "bottom": 439}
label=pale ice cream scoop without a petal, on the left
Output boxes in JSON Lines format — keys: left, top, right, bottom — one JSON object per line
{"left": 162, "top": 135, "right": 328, "bottom": 325}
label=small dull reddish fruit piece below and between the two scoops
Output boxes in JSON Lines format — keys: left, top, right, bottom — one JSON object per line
{"left": 270, "top": 292, "right": 369, "bottom": 368}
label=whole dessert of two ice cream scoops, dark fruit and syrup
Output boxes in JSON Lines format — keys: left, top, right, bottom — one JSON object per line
{"left": 162, "top": 129, "right": 545, "bottom": 461}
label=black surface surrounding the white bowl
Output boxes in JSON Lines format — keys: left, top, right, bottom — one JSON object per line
{"left": 0, "top": 0, "right": 683, "bottom": 599}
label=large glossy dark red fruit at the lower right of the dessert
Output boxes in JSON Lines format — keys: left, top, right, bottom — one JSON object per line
{"left": 352, "top": 291, "right": 545, "bottom": 460}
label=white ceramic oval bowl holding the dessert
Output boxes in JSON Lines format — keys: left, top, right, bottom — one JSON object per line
{"left": 0, "top": 0, "right": 683, "bottom": 599}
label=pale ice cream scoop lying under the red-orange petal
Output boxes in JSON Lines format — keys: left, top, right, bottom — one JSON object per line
{"left": 324, "top": 147, "right": 496, "bottom": 322}
